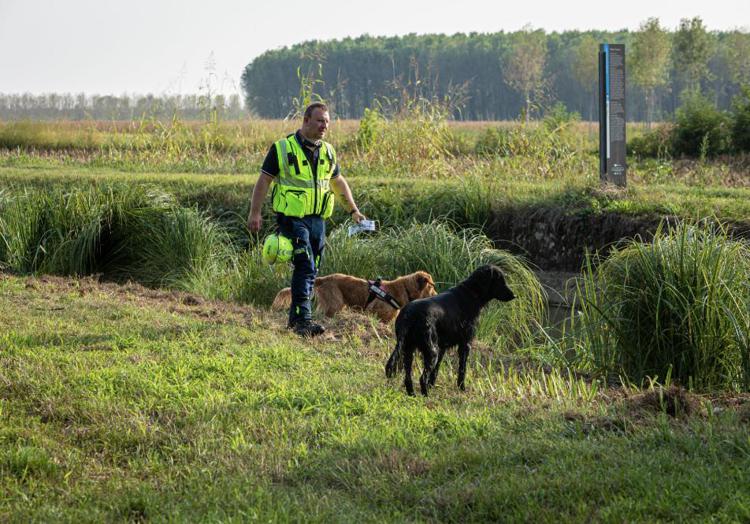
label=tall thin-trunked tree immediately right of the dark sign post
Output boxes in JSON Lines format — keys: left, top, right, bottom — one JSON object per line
{"left": 630, "top": 18, "right": 671, "bottom": 127}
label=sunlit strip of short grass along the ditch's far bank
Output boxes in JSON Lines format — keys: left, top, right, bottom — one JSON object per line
{"left": 0, "top": 162, "right": 750, "bottom": 227}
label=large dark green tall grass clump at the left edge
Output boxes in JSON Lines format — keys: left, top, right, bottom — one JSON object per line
{"left": 0, "top": 185, "right": 228, "bottom": 287}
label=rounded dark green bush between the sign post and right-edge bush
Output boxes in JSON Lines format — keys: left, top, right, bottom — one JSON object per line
{"left": 672, "top": 93, "right": 730, "bottom": 158}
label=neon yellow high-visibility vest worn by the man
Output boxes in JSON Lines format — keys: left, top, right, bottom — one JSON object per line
{"left": 271, "top": 134, "right": 336, "bottom": 218}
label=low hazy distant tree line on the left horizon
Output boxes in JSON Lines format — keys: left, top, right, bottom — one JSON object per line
{"left": 0, "top": 93, "right": 247, "bottom": 120}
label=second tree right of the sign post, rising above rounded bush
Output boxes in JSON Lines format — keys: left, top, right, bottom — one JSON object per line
{"left": 673, "top": 16, "right": 715, "bottom": 92}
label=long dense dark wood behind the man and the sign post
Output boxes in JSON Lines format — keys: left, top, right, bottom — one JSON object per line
{"left": 242, "top": 17, "right": 750, "bottom": 121}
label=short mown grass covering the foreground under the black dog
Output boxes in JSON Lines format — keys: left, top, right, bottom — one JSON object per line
{"left": 0, "top": 275, "right": 750, "bottom": 522}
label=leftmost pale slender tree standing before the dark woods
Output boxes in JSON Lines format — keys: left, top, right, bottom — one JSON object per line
{"left": 503, "top": 26, "right": 547, "bottom": 118}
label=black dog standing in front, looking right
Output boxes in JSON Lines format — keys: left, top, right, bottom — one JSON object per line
{"left": 385, "top": 265, "right": 515, "bottom": 396}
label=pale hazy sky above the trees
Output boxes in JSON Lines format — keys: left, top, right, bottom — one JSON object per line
{"left": 0, "top": 0, "right": 750, "bottom": 95}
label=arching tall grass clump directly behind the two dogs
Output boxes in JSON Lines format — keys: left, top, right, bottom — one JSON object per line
{"left": 323, "top": 221, "right": 546, "bottom": 349}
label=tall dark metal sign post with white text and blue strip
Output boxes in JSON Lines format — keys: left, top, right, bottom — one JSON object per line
{"left": 599, "top": 44, "right": 627, "bottom": 187}
